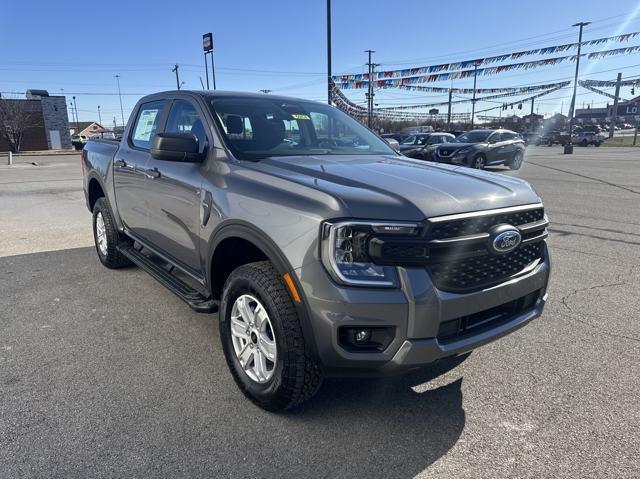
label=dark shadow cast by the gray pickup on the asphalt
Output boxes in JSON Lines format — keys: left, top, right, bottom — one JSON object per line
{"left": 0, "top": 247, "right": 466, "bottom": 478}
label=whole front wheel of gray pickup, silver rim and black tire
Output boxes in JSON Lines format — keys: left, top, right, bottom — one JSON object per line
{"left": 220, "top": 261, "right": 322, "bottom": 411}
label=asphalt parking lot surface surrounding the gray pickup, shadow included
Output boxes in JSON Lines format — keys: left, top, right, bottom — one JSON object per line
{"left": 0, "top": 147, "right": 640, "bottom": 478}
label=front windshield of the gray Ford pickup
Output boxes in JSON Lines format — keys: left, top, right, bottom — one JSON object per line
{"left": 211, "top": 95, "right": 397, "bottom": 160}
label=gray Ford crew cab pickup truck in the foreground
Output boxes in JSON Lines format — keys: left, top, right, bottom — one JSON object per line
{"left": 82, "top": 91, "right": 550, "bottom": 410}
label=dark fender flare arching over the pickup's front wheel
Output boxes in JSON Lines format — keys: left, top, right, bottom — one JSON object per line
{"left": 206, "top": 220, "right": 319, "bottom": 360}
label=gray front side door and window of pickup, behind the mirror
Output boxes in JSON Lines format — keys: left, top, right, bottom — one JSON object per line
{"left": 146, "top": 97, "right": 211, "bottom": 276}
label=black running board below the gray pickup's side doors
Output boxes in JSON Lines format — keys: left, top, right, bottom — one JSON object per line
{"left": 118, "top": 246, "right": 218, "bottom": 313}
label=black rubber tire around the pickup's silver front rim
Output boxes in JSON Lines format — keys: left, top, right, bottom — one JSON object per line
{"left": 219, "top": 261, "right": 322, "bottom": 411}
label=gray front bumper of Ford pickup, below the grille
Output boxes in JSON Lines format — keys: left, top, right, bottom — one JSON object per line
{"left": 296, "top": 243, "right": 551, "bottom": 376}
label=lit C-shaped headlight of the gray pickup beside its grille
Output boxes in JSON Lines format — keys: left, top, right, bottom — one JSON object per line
{"left": 320, "top": 221, "right": 419, "bottom": 288}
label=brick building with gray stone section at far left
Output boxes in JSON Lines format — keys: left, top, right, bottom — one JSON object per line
{"left": 0, "top": 90, "right": 71, "bottom": 151}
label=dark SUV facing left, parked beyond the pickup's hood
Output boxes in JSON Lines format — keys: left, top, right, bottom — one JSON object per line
{"left": 433, "top": 130, "right": 525, "bottom": 170}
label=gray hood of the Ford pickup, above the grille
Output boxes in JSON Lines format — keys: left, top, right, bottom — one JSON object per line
{"left": 245, "top": 155, "right": 540, "bottom": 221}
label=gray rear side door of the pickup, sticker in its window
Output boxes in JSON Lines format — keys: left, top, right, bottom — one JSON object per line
{"left": 113, "top": 100, "right": 165, "bottom": 237}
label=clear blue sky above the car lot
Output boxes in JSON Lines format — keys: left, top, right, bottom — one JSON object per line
{"left": 0, "top": 0, "right": 640, "bottom": 125}
